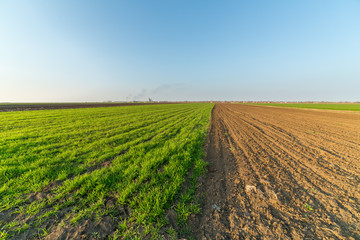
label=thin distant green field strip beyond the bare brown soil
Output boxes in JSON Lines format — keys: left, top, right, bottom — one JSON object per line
{"left": 252, "top": 103, "right": 360, "bottom": 111}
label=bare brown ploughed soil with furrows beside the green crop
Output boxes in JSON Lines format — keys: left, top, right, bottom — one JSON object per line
{"left": 192, "top": 104, "right": 360, "bottom": 239}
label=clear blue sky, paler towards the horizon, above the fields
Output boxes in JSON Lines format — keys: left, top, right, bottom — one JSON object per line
{"left": 0, "top": 0, "right": 360, "bottom": 102}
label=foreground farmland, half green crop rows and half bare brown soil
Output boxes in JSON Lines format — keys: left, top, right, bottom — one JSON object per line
{"left": 0, "top": 103, "right": 360, "bottom": 240}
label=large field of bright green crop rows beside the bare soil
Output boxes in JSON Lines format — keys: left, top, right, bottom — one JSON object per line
{"left": 0, "top": 103, "right": 213, "bottom": 239}
